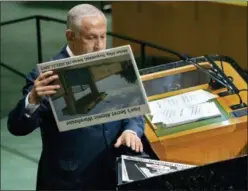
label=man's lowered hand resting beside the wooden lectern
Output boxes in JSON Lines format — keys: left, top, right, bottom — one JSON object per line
{"left": 114, "top": 131, "right": 143, "bottom": 152}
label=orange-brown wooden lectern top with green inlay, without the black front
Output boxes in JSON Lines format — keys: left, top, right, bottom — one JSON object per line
{"left": 140, "top": 56, "right": 247, "bottom": 165}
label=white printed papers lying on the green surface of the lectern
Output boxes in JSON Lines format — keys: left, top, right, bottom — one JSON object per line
{"left": 149, "top": 90, "right": 221, "bottom": 127}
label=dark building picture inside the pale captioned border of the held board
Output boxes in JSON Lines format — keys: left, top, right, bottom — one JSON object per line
{"left": 51, "top": 56, "right": 145, "bottom": 121}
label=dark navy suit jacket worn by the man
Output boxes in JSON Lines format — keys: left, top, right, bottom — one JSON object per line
{"left": 8, "top": 47, "right": 144, "bottom": 190}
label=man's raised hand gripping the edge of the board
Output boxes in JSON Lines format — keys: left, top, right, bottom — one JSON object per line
{"left": 28, "top": 71, "right": 60, "bottom": 104}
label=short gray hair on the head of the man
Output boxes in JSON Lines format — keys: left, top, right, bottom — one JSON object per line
{"left": 67, "top": 4, "right": 106, "bottom": 32}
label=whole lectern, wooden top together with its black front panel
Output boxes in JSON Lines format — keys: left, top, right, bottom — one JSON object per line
{"left": 117, "top": 56, "right": 247, "bottom": 190}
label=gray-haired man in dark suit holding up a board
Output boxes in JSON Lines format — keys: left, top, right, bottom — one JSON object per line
{"left": 8, "top": 4, "right": 144, "bottom": 190}
